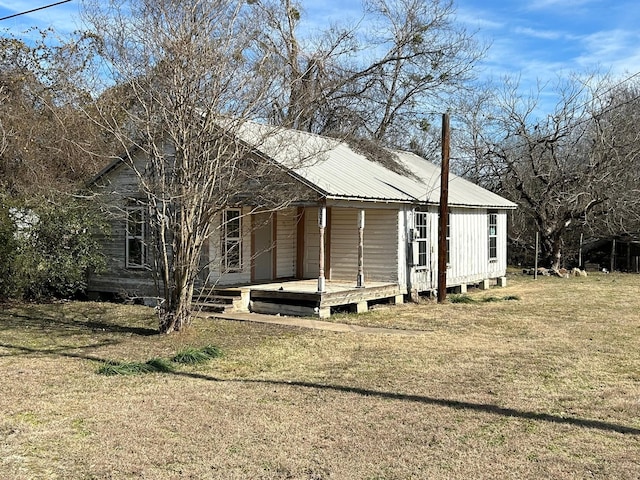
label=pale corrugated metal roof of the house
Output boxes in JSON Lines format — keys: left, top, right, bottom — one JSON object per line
{"left": 240, "top": 123, "right": 516, "bottom": 208}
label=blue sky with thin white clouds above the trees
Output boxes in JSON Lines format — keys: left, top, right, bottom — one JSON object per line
{"left": 0, "top": 0, "right": 640, "bottom": 109}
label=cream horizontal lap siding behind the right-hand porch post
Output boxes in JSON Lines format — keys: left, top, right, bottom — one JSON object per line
{"left": 331, "top": 208, "right": 398, "bottom": 282}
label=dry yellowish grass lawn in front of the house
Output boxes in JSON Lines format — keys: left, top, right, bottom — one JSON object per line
{"left": 0, "top": 274, "right": 640, "bottom": 480}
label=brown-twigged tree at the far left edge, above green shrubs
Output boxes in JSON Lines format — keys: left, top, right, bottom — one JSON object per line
{"left": 0, "top": 31, "right": 101, "bottom": 196}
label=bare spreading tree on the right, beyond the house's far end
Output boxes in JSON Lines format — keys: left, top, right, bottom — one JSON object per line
{"left": 470, "top": 77, "right": 626, "bottom": 268}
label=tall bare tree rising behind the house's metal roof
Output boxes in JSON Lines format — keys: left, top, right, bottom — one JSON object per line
{"left": 252, "top": 0, "right": 483, "bottom": 147}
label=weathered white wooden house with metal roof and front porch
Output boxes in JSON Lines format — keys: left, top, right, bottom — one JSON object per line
{"left": 89, "top": 123, "right": 515, "bottom": 317}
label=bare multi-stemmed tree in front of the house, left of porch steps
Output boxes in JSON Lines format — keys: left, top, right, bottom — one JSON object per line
{"left": 85, "top": 0, "right": 320, "bottom": 332}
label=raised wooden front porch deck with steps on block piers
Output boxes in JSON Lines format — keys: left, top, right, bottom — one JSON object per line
{"left": 194, "top": 280, "right": 407, "bottom": 318}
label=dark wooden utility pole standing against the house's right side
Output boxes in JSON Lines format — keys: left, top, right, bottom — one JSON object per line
{"left": 438, "top": 113, "right": 450, "bottom": 303}
